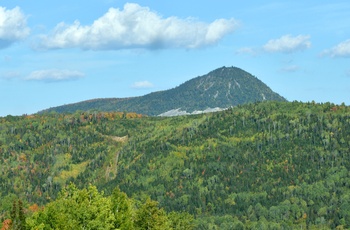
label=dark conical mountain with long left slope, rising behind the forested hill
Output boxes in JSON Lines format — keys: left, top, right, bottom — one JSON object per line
{"left": 40, "top": 67, "right": 286, "bottom": 116}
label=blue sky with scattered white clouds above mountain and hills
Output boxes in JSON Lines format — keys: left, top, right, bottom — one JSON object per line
{"left": 0, "top": 0, "right": 350, "bottom": 116}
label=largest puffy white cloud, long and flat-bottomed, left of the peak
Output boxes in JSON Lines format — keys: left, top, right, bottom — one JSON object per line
{"left": 39, "top": 3, "right": 238, "bottom": 50}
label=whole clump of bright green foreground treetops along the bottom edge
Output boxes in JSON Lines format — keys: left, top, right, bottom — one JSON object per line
{"left": 26, "top": 184, "right": 193, "bottom": 230}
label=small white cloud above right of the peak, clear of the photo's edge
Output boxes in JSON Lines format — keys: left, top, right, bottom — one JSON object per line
{"left": 263, "top": 35, "right": 311, "bottom": 53}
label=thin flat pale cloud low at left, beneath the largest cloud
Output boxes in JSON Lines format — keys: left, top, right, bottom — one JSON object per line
{"left": 25, "top": 69, "right": 84, "bottom": 82}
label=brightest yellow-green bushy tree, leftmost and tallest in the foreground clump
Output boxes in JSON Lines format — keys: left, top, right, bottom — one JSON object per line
{"left": 27, "top": 184, "right": 115, "bottom": 229}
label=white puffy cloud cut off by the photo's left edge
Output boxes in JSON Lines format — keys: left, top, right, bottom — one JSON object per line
{"left": 0, "top": 7, "right": 30, "bottom": 49}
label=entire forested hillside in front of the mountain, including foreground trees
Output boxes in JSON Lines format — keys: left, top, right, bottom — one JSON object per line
{"left": 0, "top": 102, "right": 350, "bottom": 229}
